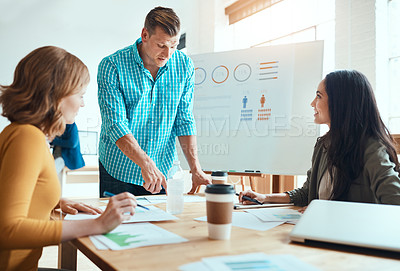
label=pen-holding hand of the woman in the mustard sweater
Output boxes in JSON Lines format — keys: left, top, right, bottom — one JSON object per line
{"left": 96, "top": 192, "right": 137, "bottom": 233}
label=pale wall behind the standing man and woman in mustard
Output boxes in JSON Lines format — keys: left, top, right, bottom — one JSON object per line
{"left": 0, "top": 0, "right": 214, "bottom": 164}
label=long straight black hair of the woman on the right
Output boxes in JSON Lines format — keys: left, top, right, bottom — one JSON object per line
{"left": 321, "top": 70, "right": 400, "bottom": 200}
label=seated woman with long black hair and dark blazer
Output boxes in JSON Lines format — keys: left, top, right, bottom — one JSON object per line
{"left": 239, "top": 70, "right": 400, "bottom": 211}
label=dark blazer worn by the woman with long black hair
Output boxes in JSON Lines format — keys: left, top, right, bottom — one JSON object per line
{"left": 286, "top": 138, "right": 400, "bottom": 206}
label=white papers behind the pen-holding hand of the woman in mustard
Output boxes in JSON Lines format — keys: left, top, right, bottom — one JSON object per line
{"left": 64, "top": 206, "right": 178, "bottom": 223}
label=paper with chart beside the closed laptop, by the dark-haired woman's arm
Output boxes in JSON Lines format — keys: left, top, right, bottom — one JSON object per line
{"left": 245, "top": 208, "right": 302, "bottom": 223}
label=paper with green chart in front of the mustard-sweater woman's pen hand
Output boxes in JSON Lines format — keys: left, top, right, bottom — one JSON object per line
{"left": 89, "top": 223, "right": 188, "bottom": 250}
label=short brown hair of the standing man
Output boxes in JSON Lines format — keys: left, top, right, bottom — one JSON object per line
{"left": 144, "top": 7, "right": 181, "bottom": 37}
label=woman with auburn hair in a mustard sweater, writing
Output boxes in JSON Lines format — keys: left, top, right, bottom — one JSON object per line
{"left": 0, "top": 46, "right": 136, "bottom": 270}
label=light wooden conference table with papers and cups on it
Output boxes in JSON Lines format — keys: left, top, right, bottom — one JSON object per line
{"left": 59, "top": 199, "right": 400, "bottom": 271}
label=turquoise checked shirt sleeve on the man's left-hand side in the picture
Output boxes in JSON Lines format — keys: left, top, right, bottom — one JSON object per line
{"left": 97, "top": 58, "right": 131, "bottom": 142}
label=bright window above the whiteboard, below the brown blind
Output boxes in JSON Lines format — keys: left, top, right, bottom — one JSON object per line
{"left": 229, "top": 0, "right": 335, "bottom": 74}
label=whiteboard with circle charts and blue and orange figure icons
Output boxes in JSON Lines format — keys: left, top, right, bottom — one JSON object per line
{"left": 178, "top": 41, "right": 323, "bottom": 175}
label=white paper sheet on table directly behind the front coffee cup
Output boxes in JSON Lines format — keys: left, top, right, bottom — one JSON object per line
{"left": 195, "top": 212, "right": 284, "bottom": 231}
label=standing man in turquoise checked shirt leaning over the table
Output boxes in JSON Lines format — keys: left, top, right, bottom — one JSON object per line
{"left": 97, "top": 7, "right": 210, "bottom": 196}
